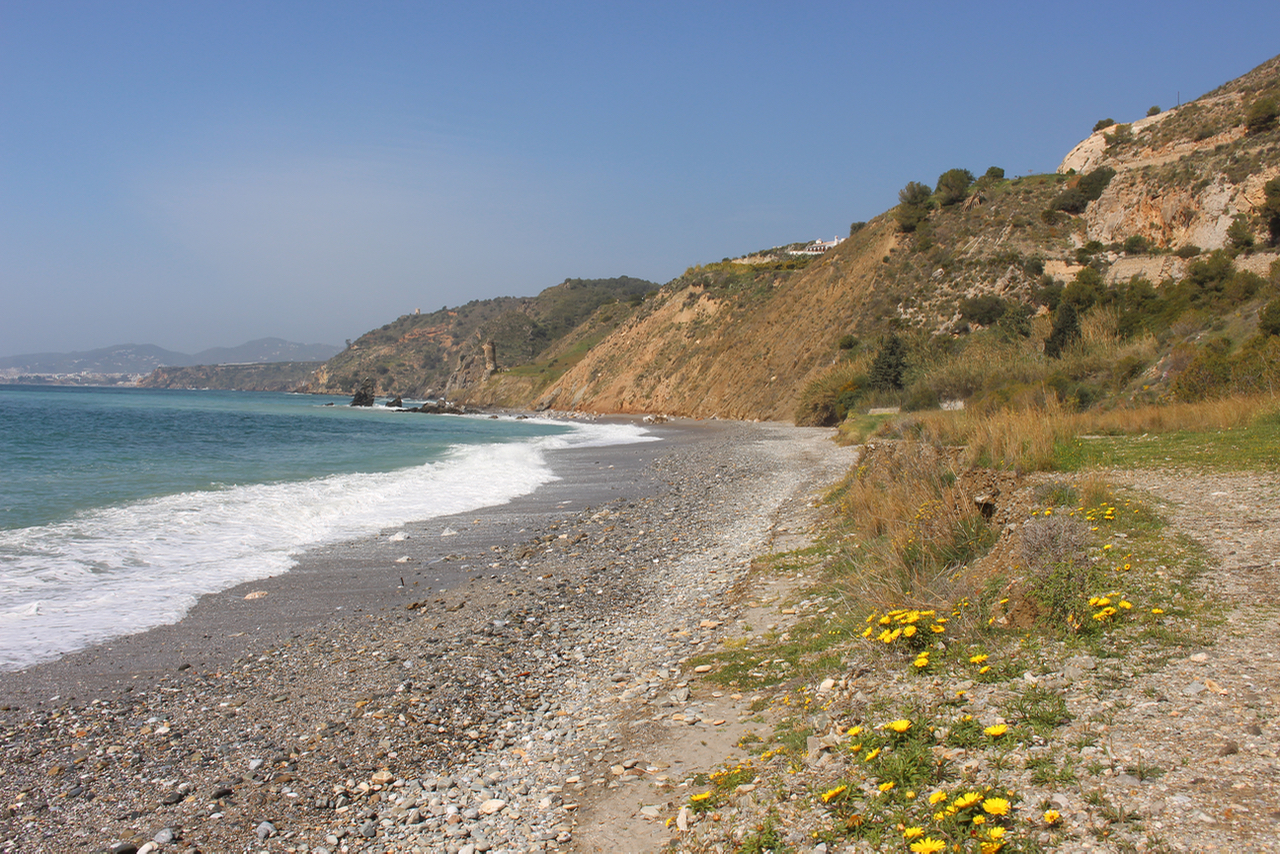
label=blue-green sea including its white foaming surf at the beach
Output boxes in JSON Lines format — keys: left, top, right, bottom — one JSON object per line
{"left": 0, "top": 385, "right": 653, "bottom": 671}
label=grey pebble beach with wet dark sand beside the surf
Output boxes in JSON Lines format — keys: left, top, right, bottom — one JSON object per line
{"left": 0, "top": 424, "right": 852, "bottom": 854}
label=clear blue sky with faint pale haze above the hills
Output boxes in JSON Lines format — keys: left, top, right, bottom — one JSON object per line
{"left": 0, "top": 0, "right": 1280, "bottom": 356}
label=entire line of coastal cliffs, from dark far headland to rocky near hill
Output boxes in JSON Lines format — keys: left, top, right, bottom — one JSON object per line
{"left": 301, "top": 50, "right": 1280, "bottom": 420}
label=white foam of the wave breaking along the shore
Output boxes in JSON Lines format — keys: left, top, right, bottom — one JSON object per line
{"left": 0, "top": 424, "right": 652, "bottom": 670}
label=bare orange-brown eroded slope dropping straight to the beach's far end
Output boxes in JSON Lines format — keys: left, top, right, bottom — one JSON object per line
{"left": 522, "top": 218, "right": 899, "bottom": 420}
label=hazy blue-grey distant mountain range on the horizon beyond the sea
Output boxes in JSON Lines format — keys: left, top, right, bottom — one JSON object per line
{"left": 0, "top": 338, "right": 342, "bottom": 375}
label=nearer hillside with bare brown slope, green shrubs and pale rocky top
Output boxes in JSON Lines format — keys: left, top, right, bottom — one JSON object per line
{"left": 450, "top": 51, "right": 1280, "bottom": 424}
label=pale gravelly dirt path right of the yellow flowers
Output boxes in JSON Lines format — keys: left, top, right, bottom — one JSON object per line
{"left": 1108, "top": 471, "right": 1280, "bottom": 851}
